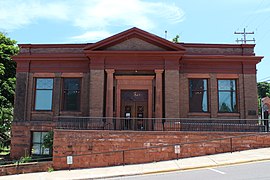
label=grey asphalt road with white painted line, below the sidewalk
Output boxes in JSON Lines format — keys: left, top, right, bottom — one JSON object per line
{"left": 107, "top": 161, "right": 270, "bottom": 180}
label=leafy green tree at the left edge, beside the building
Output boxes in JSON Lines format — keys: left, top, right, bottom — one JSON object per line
{"left": 0, "top": 33, "right": 19, "bottom": 147}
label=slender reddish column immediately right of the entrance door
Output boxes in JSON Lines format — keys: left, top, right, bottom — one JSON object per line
{"left": 155, "top": 69, "right": 164, "bottom": 118}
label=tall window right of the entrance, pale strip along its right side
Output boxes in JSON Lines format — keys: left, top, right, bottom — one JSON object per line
{"left": 189, "top": 79, "right": 208, "bottom": 112}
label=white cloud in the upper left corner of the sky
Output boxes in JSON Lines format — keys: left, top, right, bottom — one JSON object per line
{"left": 0, "top": 0, "right": 67, "bottom": 31}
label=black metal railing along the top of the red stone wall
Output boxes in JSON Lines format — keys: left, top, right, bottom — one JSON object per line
{"left": 57, "top": 116, "right": 269, "bottom": 132}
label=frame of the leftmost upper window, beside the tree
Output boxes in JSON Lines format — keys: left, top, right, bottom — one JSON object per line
{"left": 33, "top": 77, "right": 55, "bottom": 111}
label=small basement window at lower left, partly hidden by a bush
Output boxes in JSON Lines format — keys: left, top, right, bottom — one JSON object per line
{"left": 32, "top": 132, "right": 50, "bottom": 155}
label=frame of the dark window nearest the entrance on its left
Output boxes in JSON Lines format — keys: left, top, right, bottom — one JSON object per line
{"left": 61, "top": 77, "right": 82, "bottom": 112}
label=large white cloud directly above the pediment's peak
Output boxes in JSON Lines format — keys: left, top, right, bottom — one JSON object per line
{"left": 69, "top": 0, "right": 184, "bottom": 30}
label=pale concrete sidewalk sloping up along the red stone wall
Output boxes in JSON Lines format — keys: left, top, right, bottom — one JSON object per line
{"left": 0, "top": 148, "right": 270, "bottom": 180}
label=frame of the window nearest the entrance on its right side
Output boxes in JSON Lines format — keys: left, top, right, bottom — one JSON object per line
{"left": 188, "top": 78, "right": 210, "bottom": 113}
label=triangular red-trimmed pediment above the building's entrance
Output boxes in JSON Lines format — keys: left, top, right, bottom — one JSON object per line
{"left": 84, "top": 27, "right": 185, "bottom": 51}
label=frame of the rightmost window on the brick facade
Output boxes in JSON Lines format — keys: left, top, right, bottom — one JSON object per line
{"left": 217, "top": 78, "right": 239, "bottom": 113}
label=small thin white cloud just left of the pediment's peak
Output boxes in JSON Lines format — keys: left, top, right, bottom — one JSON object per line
{"left": 71, "top": 31, "right": 112, "bottom": 42}
